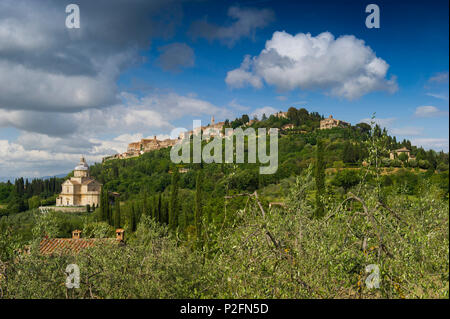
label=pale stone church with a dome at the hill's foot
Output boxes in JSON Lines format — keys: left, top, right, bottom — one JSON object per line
{"left": 56, "top": 157, "right": 102, "bottom": 206}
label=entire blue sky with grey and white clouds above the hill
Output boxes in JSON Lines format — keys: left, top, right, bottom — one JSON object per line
{"left": 0, "top": 0, "right": 449, "bottom": 177}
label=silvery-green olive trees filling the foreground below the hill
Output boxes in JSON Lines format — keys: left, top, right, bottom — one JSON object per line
{"left": 0, "top": 170, "right": 449, "bottom": 298}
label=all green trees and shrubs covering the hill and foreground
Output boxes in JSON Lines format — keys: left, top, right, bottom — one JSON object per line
{"left": 0, "top": 108, "right": 449, "bottom": 298}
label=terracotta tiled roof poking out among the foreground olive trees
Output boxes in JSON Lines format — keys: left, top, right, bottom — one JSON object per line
{"left": 39, "top": 238, "right": 120, "bottom": 255}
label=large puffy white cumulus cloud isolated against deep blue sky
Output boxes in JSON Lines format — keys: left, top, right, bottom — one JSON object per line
{"left": 225, "top": 31, "right": 397, "bottom": 99}
